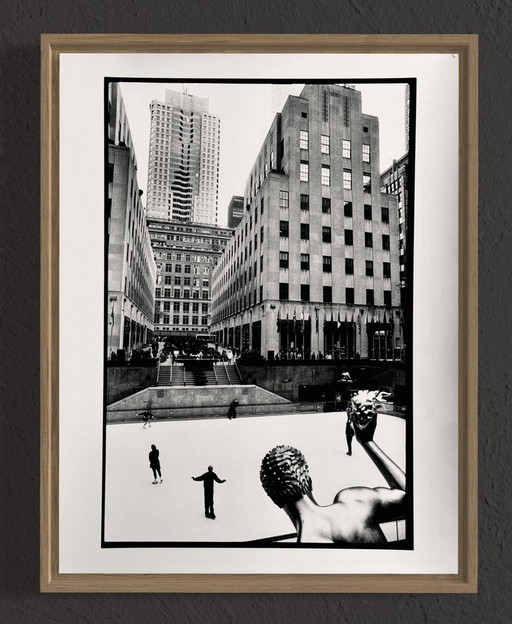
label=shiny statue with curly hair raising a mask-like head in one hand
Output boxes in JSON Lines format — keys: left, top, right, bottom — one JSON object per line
{"left": 260, "top": 390, "right": 405, "bottom": 544}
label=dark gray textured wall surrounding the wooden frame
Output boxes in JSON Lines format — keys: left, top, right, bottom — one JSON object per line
{"left": 0, "top": 0, "right": 506, "bottom": 624}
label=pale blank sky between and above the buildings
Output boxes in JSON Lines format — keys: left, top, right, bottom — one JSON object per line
{"left": 121, "top": 82, "right": 405, "bottom": 226}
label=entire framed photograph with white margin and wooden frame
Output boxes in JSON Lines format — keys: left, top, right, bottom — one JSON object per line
{"left": 41, "top": 35, "right": 477, "bottom": 593}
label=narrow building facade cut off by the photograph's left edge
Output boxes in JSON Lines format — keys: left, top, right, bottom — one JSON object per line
{"left": 106, "top": 83, "right": 156, "bottom": 358}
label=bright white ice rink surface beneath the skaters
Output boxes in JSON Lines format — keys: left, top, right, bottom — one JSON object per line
{"left": 105, "top": 412, "right": 405, "bottom": 542}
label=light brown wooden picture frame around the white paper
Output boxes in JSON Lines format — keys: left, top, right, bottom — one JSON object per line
{"left": 40, "top": 34, "right": 478, "bottom": 593}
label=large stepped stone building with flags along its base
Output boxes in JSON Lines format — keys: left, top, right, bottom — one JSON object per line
{"left": 212, "top": 85, "right": 401, "bottom": 359}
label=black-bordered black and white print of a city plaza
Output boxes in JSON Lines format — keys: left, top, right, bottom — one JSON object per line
{"left": 105, "top": 74, "right": 417, "bottom": 550}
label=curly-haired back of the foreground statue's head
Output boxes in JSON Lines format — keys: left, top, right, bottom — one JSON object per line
{"left": 260, "top": 445, "right": 313, "bottom": 507}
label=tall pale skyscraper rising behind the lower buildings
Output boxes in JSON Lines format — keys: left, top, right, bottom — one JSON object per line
{"left": 147, "top": 89, "right": 220, "bottom": 225}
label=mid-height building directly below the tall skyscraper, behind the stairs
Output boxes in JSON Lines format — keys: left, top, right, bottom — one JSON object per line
{"left": 148, "top": 217, "right": 233, "bottom": 337}
